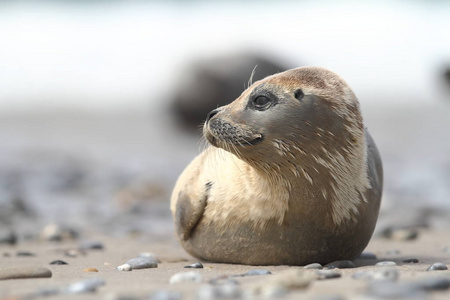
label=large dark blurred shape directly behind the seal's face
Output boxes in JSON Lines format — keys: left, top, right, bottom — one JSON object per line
{"left": 171, "top": 54, "right": 287, "bottom": 128}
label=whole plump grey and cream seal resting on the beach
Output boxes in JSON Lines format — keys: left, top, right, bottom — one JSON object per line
{"left": 171, "top": 67, "right": 383, "bottom": 265}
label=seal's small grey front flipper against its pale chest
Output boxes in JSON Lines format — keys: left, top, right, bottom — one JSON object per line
{"left": 175, "top": 183, "right": 210, "bottom": 241}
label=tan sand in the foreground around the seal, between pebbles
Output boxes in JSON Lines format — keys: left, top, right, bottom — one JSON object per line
{"left": 0, "top": 229, "right": 450, "bottom": 299}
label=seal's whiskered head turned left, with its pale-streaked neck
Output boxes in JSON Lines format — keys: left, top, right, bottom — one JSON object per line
{"left": 203, "top": 67, "right": 370, "bottom": 223}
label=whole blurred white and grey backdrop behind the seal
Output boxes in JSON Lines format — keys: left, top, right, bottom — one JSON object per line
{"left": 0, "top": 0, "right": 450, "bottom": 241}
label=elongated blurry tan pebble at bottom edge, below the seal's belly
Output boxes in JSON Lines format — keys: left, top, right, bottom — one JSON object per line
{"left": 254, "top": 268, "right": 314, "bottom": 297}
